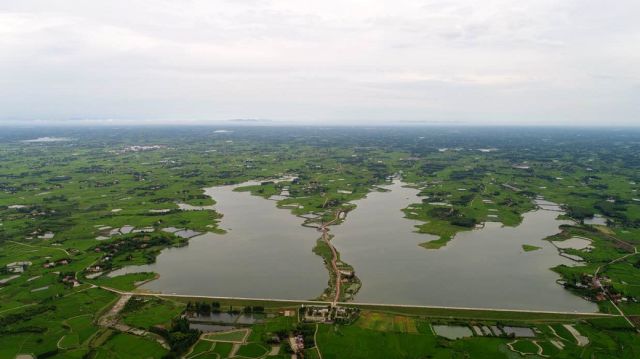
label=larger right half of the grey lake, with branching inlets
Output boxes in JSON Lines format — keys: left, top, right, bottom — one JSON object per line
{"left": 331, "top": 182, "right": 597, "bottom": 312}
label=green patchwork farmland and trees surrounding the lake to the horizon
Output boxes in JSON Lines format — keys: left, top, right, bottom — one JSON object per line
{"left": 0, "top": 127, "right": 640, "bottom": 358}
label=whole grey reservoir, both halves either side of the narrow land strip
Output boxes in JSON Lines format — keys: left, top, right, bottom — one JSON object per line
{"left": 114, "top": 181, "right": 597, "bottom": 312}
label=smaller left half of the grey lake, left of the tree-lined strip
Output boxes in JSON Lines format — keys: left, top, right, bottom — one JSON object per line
{"left": 114, "top": 186, "right": 328, "bottom": 299}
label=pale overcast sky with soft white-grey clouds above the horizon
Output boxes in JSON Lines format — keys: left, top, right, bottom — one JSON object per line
{"left": 0, "top": 0, "right": 640, "bottom": 125}
